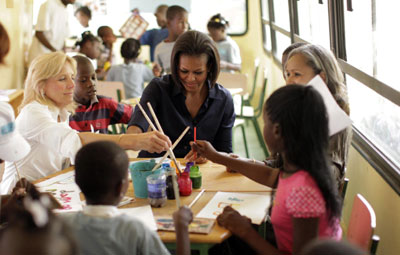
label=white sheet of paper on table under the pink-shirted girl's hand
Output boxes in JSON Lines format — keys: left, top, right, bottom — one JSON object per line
{"left": 196, "top": 192, "right": 271, "bottom": 225}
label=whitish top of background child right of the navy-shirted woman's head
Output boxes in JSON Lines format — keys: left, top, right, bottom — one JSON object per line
{"left": 216, "top": 36, "right": 242, "bottom": 72}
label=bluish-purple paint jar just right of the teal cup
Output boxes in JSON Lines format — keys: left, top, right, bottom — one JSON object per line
{"left": 146, "top": 172, "right": 167, "bottom": 207}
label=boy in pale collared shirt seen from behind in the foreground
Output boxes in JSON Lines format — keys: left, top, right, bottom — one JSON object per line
{"left": 62, "top": 141, "right": 170, "bottom": 254}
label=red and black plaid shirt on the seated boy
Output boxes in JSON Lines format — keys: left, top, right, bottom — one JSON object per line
{"left": 69, "top": 96, "right": 133, "bottom": 134}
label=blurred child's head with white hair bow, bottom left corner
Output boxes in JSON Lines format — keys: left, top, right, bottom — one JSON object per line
{"left": 0, "top": 197, "right": 78, "bottom": 255}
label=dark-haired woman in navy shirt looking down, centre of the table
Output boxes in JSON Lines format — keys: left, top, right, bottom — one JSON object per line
{"left": 128, "top": 31, "right": 235, "bottom": 163}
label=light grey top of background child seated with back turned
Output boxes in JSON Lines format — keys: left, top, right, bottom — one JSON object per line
{"left": 107, "top": 63, "right": 154, "bottom": 98}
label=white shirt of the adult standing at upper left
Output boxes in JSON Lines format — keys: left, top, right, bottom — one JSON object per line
{"left": 28, "top": 0, "right": 69, "bottom": 63}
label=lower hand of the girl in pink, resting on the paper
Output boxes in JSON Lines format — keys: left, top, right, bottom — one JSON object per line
{"left": 217, "top": 206, "right": 252, "bottom": 239}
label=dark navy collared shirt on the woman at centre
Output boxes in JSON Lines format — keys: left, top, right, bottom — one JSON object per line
{"left": 129, "top": 75, "right": 235, "bottom": 157}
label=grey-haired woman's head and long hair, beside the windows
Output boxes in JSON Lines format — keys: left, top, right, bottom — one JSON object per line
{"left": 284, "top": 44, "right": 351, "bottom": 186}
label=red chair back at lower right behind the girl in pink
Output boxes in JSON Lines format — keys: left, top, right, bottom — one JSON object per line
{"left": 347, "top": 194, "right": 379, "bottom": 254}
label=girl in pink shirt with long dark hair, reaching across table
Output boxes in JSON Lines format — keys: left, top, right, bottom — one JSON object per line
{"left": 189, "top": 85, "right": 342, "bottom": 254}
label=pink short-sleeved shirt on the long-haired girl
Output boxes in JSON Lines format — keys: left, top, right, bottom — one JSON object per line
{"left": 271, "top": 170, "right": 342, "bottom": 254}
